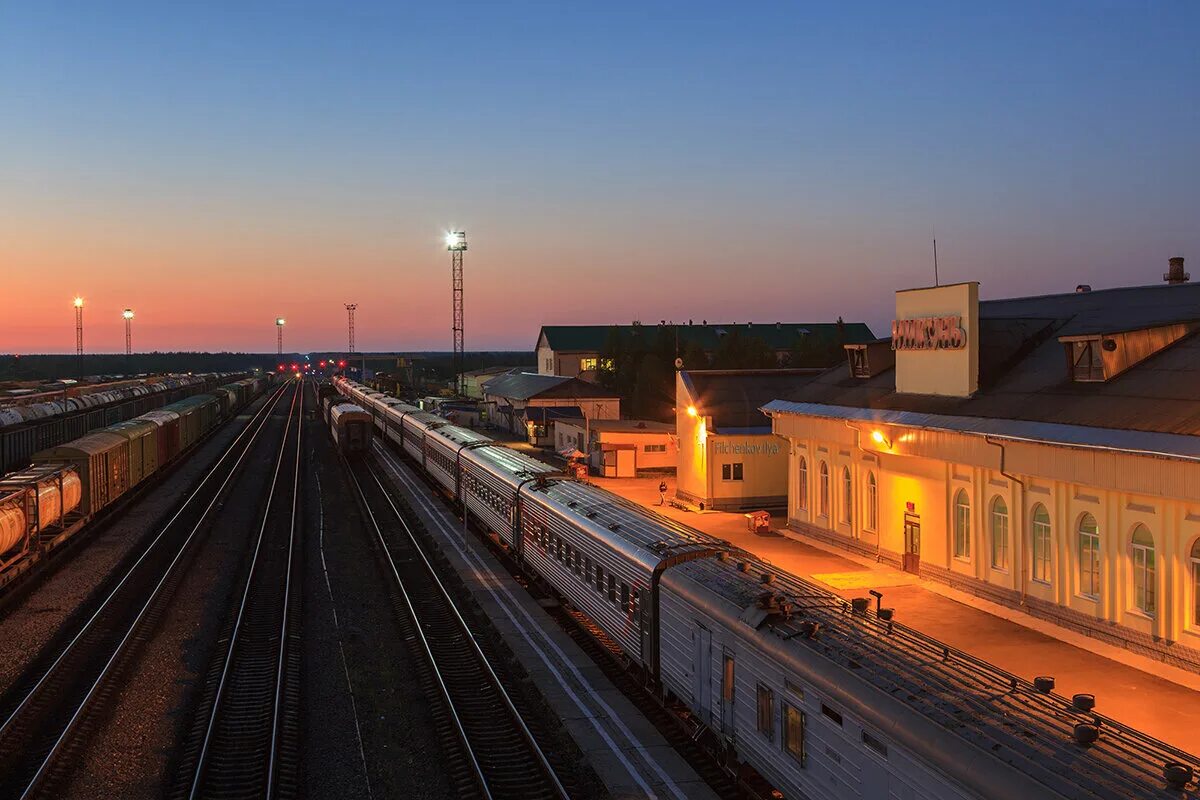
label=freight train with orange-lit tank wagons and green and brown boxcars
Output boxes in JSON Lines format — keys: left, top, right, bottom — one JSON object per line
{"left": 0, "top": 378, "right": 270, "bottom": 585}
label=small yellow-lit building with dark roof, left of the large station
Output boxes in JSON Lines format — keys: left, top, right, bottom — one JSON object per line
{"left": 676, "top": 369, "right": 821, "bottom": 511}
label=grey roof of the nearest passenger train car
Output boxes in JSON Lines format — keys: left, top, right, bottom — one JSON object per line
{"left": 661, "top": 551, "right": 1200, "bottom": 800}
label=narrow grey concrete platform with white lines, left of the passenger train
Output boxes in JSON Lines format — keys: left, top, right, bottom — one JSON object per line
{"left": 376, "top": 443, "right": 716, "bottom": 800}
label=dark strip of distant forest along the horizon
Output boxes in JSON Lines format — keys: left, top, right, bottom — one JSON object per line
{"left": 0, "top": 350, "right": 534, "bottom": 380}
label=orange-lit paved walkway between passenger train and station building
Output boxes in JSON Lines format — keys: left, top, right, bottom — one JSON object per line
{"left": 571, "top": 477, "right": 1200, "bottom": 753}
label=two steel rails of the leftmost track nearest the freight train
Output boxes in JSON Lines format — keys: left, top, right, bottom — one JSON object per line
{"left": 0, "top": 386, "right": 295, "bottom": 799}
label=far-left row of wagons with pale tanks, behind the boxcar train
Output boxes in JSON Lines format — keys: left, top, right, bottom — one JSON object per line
{"left": 0, "top": 373, "right": 247, "bottom": 474}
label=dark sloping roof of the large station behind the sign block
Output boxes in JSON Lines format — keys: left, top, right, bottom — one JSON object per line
{"left": 773, "top": 283, "right": 1200, "bottom": 435}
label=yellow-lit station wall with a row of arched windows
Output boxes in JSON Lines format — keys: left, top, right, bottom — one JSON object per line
{"left": 775, "top": 415, "right": 1200, "bottom": 648}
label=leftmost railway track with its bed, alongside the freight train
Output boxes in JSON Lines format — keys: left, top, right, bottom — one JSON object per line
{"left": 0, "top": 386, "right": 294, "bottom": 799}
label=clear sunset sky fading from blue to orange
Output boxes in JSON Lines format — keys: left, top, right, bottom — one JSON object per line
{"left": 0, "top": 0, "right": 1200, "bottom": 353}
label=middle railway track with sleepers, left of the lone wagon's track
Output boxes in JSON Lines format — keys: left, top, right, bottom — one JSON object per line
{"left": 172, "top": 384, "right": 304, "bottom": 799}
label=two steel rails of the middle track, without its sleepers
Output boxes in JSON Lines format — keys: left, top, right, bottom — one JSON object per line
{"left": 188, "top": 381, "right": 304, "bottom": 798}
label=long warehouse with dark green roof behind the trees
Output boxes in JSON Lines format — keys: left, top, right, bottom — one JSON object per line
{"left": 535, "top": 319, "right": 875, "bottom": 379}
